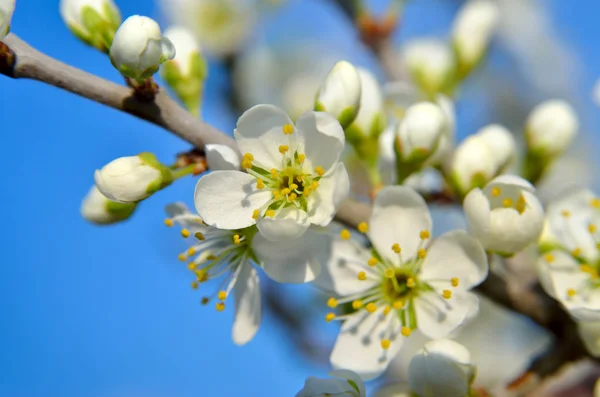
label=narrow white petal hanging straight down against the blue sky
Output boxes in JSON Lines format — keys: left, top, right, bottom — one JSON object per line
{"left": 232, "top": 261, "right": 261, "bottom": 345}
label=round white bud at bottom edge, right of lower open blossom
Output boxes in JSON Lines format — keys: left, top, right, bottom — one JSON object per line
{"left": 408, "top": 339, "right": 475, "bottom": 397}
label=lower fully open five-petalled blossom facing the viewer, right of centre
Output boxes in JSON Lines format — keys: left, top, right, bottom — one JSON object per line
{"left": 315, "top": 186, "right": 488, "bottom": 379}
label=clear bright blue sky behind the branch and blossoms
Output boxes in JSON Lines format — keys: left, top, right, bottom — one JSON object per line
{"left": 0, "top": 0, "right": 600, "bottom": 397}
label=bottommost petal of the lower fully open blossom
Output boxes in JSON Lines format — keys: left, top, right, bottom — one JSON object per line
{"left": 331, "top": 308, "right": 404, "bottom": 380}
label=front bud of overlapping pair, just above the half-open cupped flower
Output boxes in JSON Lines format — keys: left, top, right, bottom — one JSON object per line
{"left": 450, "top": 135, "right": 497, "bottom": 195}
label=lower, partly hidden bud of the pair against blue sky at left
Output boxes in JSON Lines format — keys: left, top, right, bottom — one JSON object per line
{"left": 81, "top": 186, "right": 137, "bottom": 225}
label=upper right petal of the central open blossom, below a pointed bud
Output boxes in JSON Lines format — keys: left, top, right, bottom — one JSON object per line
{"left": 296, "top": 111, "right": 345, "bottom": 171}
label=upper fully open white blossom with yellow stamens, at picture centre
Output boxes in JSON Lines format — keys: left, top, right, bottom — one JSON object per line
{"left": 195, "top": 105, "right": 349, "bottom": 241}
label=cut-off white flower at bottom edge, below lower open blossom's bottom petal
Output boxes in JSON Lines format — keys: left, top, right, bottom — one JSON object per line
{"left": 296, "top": 369, "right": 367, "bottom": 397}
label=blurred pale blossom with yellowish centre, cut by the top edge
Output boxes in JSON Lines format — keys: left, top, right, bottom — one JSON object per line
{"left": 160, "top": 0, "right": 256, "bottom": 57}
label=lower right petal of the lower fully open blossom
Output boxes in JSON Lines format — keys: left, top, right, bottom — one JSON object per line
{"left": 415, "top": 289, "right": 479, "bottom": 339}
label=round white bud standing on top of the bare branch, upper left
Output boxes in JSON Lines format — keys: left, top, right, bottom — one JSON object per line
{"left": 110, "top": 15, "right": 175, "bottom": 80}
